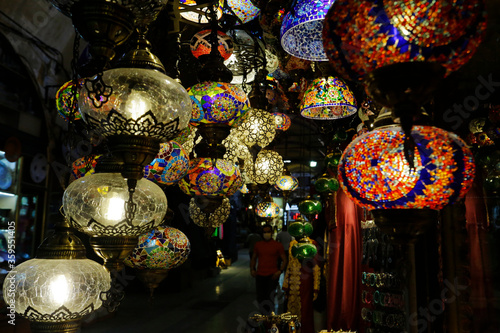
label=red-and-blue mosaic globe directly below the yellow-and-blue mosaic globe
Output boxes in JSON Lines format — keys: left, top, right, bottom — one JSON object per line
{"left": 179, "top": 158, "right": 243, "bottom": 196}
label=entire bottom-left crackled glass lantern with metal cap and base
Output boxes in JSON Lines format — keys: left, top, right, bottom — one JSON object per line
{"left": 3, "top": 218, "right": 110, "bottom": 333}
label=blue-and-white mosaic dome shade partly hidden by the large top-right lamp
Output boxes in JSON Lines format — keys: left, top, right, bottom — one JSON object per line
{"left": 281, "top": 0, "right": 335, "bottom": 61}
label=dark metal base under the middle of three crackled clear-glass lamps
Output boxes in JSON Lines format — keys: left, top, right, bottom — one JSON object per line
{"left": 90, "top": 236, "right": 137, "bottom": 272}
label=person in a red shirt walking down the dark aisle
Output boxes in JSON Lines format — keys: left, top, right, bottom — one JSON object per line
{"left": 250, "top": 224, "right": 287, "bottom": 315}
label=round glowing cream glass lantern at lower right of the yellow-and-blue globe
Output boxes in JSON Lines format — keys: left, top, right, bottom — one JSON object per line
{"left": 238, "top": 108, "right": 276, "bottom": 147}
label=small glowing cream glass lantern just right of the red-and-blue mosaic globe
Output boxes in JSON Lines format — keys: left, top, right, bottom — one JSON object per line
{"left": 252, "top": 149, "right": 284, "bottom": 185}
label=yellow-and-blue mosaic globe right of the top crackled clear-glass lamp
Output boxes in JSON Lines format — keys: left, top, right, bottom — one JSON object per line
{"left": 188, "top": 81, "right": 249, "bottom": 126}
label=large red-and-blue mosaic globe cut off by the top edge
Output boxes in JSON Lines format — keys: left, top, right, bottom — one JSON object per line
{"left": 323, "top": 0, "right": 486, "bottom": 80}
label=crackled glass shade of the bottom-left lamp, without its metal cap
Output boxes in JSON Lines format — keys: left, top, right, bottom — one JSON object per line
{"left": 3, "top": 259, "right": 111, "bottom": 322}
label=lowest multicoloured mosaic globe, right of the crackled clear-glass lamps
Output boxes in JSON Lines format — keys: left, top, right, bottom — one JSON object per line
{"left": 123, "top": 227, "right": 191, "bottom": 269}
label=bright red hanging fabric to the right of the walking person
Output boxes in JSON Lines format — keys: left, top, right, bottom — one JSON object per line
{"left": 326, "top": 189, "right": 363, "bottom": 330}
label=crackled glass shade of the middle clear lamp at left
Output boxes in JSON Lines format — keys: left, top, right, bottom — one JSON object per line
{"left": 63, "top": 173, "right": 167, "bottom": 236}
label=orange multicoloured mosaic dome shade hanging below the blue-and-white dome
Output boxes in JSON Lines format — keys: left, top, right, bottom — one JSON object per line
{"left": 300, "top": 76, "right": 358, "bottom": 120}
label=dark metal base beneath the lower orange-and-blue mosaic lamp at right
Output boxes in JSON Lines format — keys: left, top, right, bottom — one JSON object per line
{"left": 371, "top": 209, "right": 438, "bottom": 244}
